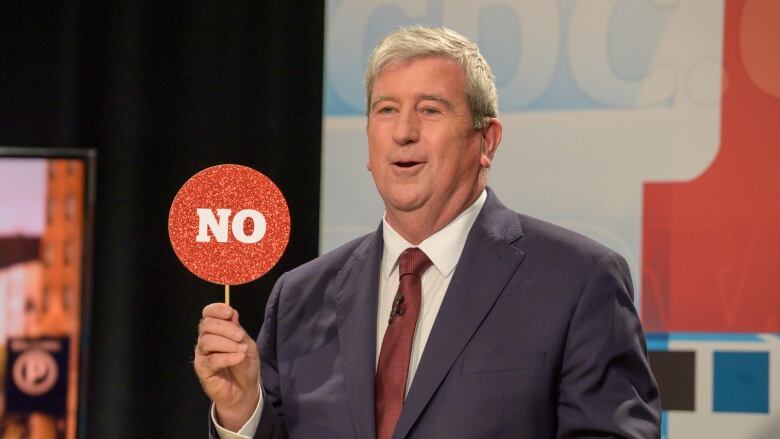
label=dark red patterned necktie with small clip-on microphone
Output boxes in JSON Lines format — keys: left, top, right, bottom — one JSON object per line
{"left": 376, "top": 248, "right": 431, "bottom": 439}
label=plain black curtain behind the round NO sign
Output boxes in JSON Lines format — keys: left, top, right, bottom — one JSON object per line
{"left": 0, "top": 1, "right": 322, "bottom": 438}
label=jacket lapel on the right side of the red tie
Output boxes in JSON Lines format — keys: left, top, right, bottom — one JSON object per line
{"left": 396, "top": 190, "right": 524, "bottom": 438}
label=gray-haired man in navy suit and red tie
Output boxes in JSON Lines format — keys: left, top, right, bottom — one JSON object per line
{"left": 195, "top": 28, "right": 660, "bottom": 438}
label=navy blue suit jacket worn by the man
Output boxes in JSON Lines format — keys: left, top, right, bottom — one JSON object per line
{"left": 212, "top": 189, "right": 660, "bottom": 439}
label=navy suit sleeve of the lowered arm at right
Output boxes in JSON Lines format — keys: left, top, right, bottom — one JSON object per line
{"left": 557, "top": 253, "right": 660, "bottom": 438}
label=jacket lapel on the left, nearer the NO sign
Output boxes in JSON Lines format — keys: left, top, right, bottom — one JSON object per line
{"left": 332, "top": 226, "right": 383, "bottom": 438}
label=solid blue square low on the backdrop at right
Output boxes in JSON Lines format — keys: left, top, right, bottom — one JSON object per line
{"left": 712, "top": 351, "right": 769, "bottom": 413}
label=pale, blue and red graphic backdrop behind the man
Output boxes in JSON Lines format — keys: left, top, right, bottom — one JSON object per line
{"left": 320, "top": 0, "right": 780, "bottom": 438}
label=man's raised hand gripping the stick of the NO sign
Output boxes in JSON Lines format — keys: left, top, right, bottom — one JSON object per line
{"left": 195, "top": 303, "right": 260, "bottom": 431}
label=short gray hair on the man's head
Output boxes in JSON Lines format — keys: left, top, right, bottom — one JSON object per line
{"left": 365, "top": 26, "right": 498, "bottom": 129}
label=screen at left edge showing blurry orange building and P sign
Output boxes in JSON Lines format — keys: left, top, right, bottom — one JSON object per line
{"left": 0, "top": 147, "right": 94, "bottom": 439}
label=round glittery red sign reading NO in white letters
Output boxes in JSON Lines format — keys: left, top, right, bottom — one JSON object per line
{"left": 168, "top": 165, "right": 290, "bottom": 285}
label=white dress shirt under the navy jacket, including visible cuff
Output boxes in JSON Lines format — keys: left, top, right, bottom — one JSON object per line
{"left": 211, "top": 189, "right": 487, "bottom": 439}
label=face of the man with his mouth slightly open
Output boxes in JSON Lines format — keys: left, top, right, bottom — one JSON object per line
{"left": 368, "top": 56, "right": 492, "bottom": 226}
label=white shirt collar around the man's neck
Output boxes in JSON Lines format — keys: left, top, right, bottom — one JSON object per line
{"left": 382, "top": 189, "right": 487, "bottom": 279}
